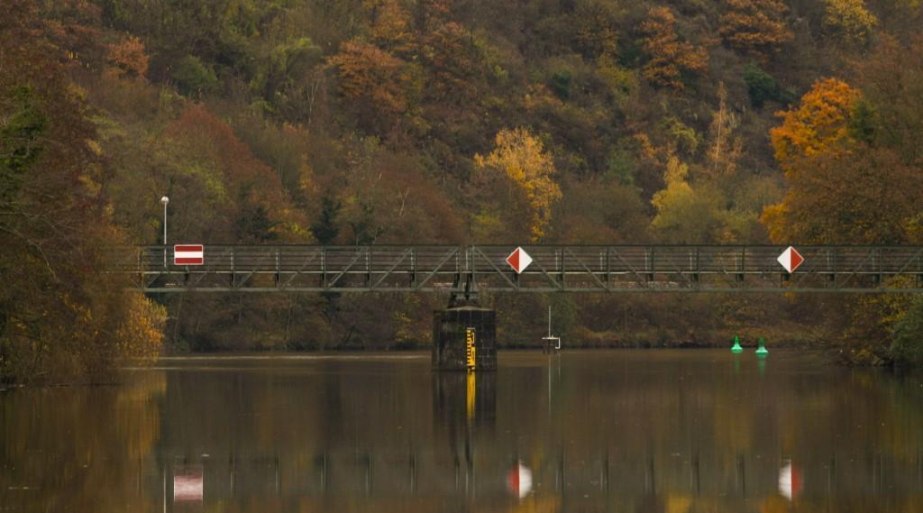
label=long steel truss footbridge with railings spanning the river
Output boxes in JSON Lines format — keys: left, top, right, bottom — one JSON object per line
{"left": 111, "top": 245, "right": 923, "bottom": 295}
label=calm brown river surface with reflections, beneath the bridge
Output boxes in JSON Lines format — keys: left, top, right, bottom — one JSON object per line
{"left": 0, "top": 351, "right": 923, "bottom": 513}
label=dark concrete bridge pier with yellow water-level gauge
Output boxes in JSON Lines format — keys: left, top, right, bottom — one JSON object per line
{"left": 433, "top": 276, "right": 497, "bottom": 372}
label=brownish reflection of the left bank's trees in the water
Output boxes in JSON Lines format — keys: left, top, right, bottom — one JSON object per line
{"left": 0, "top": 371, "right": 167, "bottom": 512}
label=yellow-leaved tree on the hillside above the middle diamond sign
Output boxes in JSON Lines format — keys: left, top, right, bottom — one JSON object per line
{"left": 474, "top": 128, "right": 561, "bottom": 242}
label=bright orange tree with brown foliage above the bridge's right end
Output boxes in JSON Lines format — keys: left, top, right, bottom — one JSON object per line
{"left": 763, "top": 79, "right": 923, "bottom": 244}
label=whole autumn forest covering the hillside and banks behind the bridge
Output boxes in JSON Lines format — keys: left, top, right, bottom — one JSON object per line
{"left": 0, "top": 0, "right": 923, "bottom": 382}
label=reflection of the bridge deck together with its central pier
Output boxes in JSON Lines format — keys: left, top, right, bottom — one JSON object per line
{"left": 160, "top": 372, "right": 923, "bottom": 504}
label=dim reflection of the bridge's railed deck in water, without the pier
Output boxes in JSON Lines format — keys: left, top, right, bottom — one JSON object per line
{"left": 164, "top": 447, "right": 923, "bottom": 501}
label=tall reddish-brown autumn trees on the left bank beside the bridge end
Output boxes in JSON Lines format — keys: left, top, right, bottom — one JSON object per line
{"left": 0, "top": 2, "right": 165, "bottom": 382}
